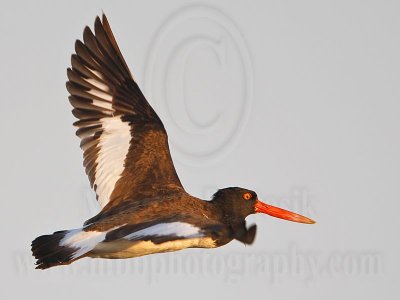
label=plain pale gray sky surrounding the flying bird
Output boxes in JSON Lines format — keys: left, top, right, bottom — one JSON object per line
{"left": 0, "top": 1, "right": 400, "bottom": 299}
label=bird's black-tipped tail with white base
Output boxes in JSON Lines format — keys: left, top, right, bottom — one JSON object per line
{"left": 31, "top": 229, "right": 96, "bottom": 269}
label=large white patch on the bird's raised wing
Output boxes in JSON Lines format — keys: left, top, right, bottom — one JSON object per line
{"left": 94, "top": 116, "right": 131, "bottom": 207}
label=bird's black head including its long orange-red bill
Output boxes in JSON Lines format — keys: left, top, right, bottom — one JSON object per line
{"left": 212, "top": 187, "right": 315, "bottom": 224}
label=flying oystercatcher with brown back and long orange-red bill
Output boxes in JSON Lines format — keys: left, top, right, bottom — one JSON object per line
{"left": 32, "top": 14, "right": 314, "bottom": 269}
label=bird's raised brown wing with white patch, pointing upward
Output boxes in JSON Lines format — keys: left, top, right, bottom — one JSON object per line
{"left": 66, "top": 14, "right": 182, "bottom": 207}
